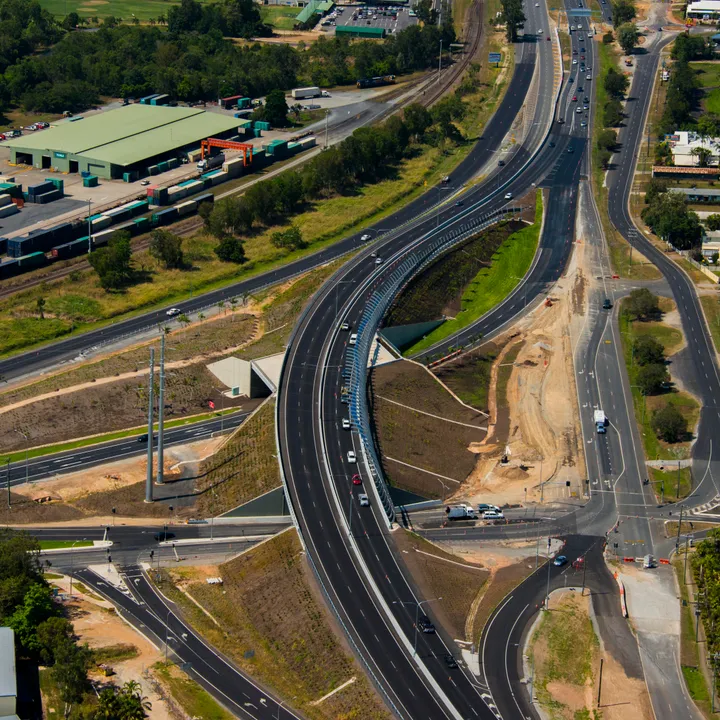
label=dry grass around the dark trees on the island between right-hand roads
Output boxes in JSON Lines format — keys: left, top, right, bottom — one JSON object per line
{"left": 619, "top": 298, "right": 699, "bottom": 466}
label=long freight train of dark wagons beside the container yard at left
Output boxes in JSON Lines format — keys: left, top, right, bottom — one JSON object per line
{"left": 0, "top": 193, "right": 215, "bottom": 280}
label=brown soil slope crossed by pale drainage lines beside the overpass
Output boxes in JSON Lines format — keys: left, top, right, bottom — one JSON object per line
{"left": 370, "top": 360, "right": 486, "bottom": 497}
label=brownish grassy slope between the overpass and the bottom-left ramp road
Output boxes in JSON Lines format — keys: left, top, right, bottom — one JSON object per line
{"left": 155, "top": 530, "right": 390, "bottom": 720}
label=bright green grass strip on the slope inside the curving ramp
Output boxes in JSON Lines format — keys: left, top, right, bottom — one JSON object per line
{"left": 404, "top": 191, "right": 543, "bottom": 356}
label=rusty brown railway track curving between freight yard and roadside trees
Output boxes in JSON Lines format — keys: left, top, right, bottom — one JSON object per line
{"left": 0, "top": 7, "right": 482, "bottom": 299}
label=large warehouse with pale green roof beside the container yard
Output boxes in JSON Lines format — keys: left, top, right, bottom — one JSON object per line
{"left": 5, "top": 104, "right": 238, "bottom": 180}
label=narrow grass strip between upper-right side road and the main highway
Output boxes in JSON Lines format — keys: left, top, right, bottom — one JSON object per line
{"left": 590, "top": 21, "right": 660, "bottom": 280}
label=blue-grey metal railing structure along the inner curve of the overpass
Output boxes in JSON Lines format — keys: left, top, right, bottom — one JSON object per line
{"left": 345, "top": 208, "right": 521, "bottom": 522}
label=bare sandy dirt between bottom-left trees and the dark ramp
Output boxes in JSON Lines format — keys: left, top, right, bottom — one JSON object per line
{"left": 53, "top": 579, "right": 178, "bottom": 720}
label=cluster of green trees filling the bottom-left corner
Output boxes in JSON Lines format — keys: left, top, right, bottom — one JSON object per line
{"left": 0, "top": 528, "right": 150, "bottom": 720}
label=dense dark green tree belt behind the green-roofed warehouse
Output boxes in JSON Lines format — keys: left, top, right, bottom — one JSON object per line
{"left": 0, "top": 0, "right": 455, "bottom": 112}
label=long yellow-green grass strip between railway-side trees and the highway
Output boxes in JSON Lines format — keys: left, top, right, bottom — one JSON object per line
{"left": 0, "top": 19, "right": 513, "bottom": 356}
